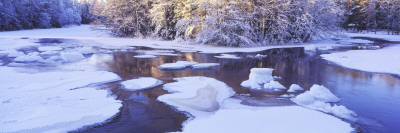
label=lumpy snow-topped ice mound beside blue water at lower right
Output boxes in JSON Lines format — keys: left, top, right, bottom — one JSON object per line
{"left": 290, "top": 85, "right": 356, "bottom": 121}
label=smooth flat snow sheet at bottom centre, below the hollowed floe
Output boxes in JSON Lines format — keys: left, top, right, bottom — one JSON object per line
{"left": 183, "top": 99, "right": 354, "bottom": 133}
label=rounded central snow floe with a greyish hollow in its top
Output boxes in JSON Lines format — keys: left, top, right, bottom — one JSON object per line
{"left": 158, "top": 77, "right": 235, "bottom": 116}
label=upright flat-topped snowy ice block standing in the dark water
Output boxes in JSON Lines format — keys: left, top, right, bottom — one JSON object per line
{"left": 240, "top": 68, "right": 274, "bottom": 89}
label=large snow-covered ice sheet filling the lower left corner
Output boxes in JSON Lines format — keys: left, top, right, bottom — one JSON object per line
{"left": 0, "top": 67, "right": 122, "bottom": 132}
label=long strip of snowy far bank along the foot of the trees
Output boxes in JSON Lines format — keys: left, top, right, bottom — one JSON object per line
{"left": 0, "top": 25, "right": 350, "bottom": 53}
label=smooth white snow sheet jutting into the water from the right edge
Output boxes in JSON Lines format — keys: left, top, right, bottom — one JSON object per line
{"left": 321, "top": 45, "right": 400, "bottom": 75}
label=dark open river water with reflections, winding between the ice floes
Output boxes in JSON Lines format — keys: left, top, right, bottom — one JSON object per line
{"left": 81, "top": 47, "right": 400, "bottom": 132}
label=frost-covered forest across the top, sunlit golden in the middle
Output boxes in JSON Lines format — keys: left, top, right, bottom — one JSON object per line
{"left": 0, "top": 0, "right": 400, "bottom": 47}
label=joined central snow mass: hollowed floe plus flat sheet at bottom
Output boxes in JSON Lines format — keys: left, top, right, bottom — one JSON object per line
{"left": 158, "top": 77, "right": 354, "bottom": 133}
